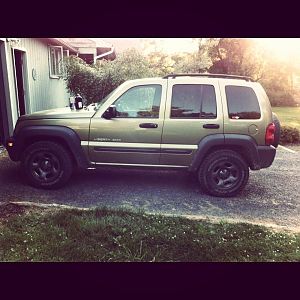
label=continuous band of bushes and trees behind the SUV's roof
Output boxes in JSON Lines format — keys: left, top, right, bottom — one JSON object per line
{"left": 65, "top": 38, "right": 300, "bottom": 106}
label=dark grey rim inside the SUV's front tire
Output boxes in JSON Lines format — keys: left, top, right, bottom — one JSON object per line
{"left": 29, "top": 151, "right": 61, "bottom": 183}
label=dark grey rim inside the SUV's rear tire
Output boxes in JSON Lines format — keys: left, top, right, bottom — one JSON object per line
{"left": 209, "top": 160, "right": 241, "bottom": 190}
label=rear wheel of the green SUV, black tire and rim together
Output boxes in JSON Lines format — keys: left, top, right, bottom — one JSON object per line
{"left": 198, "top": 150, "right": 249, "bottom": 197}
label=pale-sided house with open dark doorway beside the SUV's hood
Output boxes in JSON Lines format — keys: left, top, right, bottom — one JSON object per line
{"left": 0, "top": 38, "right": 115, "bottom": 144}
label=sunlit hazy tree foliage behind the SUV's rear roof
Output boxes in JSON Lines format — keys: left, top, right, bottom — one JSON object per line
{"left": 209, "top": 38, "right": 296, "bottom": 106}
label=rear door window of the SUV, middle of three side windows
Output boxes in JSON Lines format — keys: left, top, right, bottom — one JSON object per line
{"left": 171, "top": 84, "right": 217, "bottom": 119}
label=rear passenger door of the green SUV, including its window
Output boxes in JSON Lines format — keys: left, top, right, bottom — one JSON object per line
{"left": 160, "top": 78, "right": 223, "bottom": 166}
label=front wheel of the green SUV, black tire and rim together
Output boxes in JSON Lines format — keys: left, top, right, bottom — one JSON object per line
{"left": 21, "top": 142, "right": 73, "bottom": 189}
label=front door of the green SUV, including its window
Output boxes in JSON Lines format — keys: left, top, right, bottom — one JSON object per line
{"left": 89, "top": 79, "right": 167, "bottom": 165}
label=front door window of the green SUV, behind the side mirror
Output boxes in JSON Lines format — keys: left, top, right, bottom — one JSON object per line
{"left": 115, "top": 85, "right": 161, "bottom": 118}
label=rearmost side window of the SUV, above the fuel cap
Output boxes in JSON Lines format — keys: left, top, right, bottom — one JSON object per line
{"left": 225, "top": 85, "right": 260, "bottom": 119}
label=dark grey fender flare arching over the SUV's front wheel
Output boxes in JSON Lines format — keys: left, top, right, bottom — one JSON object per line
{"left": 13, "top": 125, "right": 89, "bottom": 168}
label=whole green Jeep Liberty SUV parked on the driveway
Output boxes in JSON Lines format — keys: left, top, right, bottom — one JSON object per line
{"left": 6, "top": 74, "right": 280, "bottom": 197}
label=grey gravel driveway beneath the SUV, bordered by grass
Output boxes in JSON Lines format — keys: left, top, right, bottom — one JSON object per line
{"left": 0, "top": 147, "right": 300, "bottom": 231}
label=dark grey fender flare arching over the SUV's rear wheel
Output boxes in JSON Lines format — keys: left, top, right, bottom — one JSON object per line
{"left": 189, "top": 134, "right": 261, "bottom": 172}
